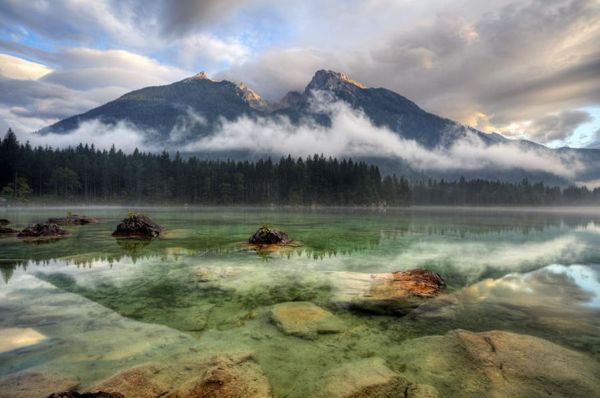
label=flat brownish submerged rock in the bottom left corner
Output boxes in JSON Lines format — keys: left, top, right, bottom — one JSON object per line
{"left": 0, "top": 372, "right": 79, "bottom": 398}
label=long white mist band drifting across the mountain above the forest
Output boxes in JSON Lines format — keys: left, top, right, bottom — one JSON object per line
{"left": 184, "top": 93, "right": 583, "bottom": 178}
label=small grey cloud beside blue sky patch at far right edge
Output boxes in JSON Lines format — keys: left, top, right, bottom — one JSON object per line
{"left": 530, "top": 111, "right": 594, "bottom": 142}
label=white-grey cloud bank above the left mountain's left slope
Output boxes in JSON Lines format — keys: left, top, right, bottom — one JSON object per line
{"left": 0, "top": 48, "right": 190, "bottom": 131}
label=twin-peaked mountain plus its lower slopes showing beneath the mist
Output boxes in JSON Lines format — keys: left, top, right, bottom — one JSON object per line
{"left": 40, "top": 70, "right": 600, "bottom": 185}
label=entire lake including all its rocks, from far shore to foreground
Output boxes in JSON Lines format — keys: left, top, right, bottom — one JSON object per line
{"left": 0, "top": 209, "right": 600, "bottom": 398}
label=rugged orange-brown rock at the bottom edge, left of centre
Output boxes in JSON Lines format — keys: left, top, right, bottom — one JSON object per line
{"left": 167, "top": 356, "right": 272, "bottom": 398}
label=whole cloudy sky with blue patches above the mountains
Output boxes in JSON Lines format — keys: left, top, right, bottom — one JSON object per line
{"left": 0, "top": 0, "right": 600, "bottom": 147}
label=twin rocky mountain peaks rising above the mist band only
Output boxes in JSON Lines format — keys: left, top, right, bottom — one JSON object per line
{"left": 42, "top": 70, "right": 498, "bottom": 148}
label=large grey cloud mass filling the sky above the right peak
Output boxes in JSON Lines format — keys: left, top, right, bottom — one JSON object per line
{"left": 216, "top": 0, "right": 600, "bottom": 141}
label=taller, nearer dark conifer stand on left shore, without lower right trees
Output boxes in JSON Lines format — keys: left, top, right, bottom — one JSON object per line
{"left": 0, "top": 130, "right": 410, "bottom": 206}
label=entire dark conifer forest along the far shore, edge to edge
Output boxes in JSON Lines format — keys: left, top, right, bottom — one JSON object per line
{"left": 0, "top": 129, "right": 600, "bottom": 206}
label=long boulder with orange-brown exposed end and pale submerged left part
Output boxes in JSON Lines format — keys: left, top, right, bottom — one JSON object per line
{"left": 330, "top": 269, "right": 445, "bottom": 315}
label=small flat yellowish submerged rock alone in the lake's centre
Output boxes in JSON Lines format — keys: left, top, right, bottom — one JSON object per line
{"left": 271, "top": 301, "right": 345, "bottom": 339}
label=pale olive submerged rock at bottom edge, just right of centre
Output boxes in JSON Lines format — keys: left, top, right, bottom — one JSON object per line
{"left": 315, "top": 358, "right": 410, "bottom": 398}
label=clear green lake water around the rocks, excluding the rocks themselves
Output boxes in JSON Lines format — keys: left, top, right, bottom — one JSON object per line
{"left": 0, "top": 208, "right": 600, "bottom": 397}
